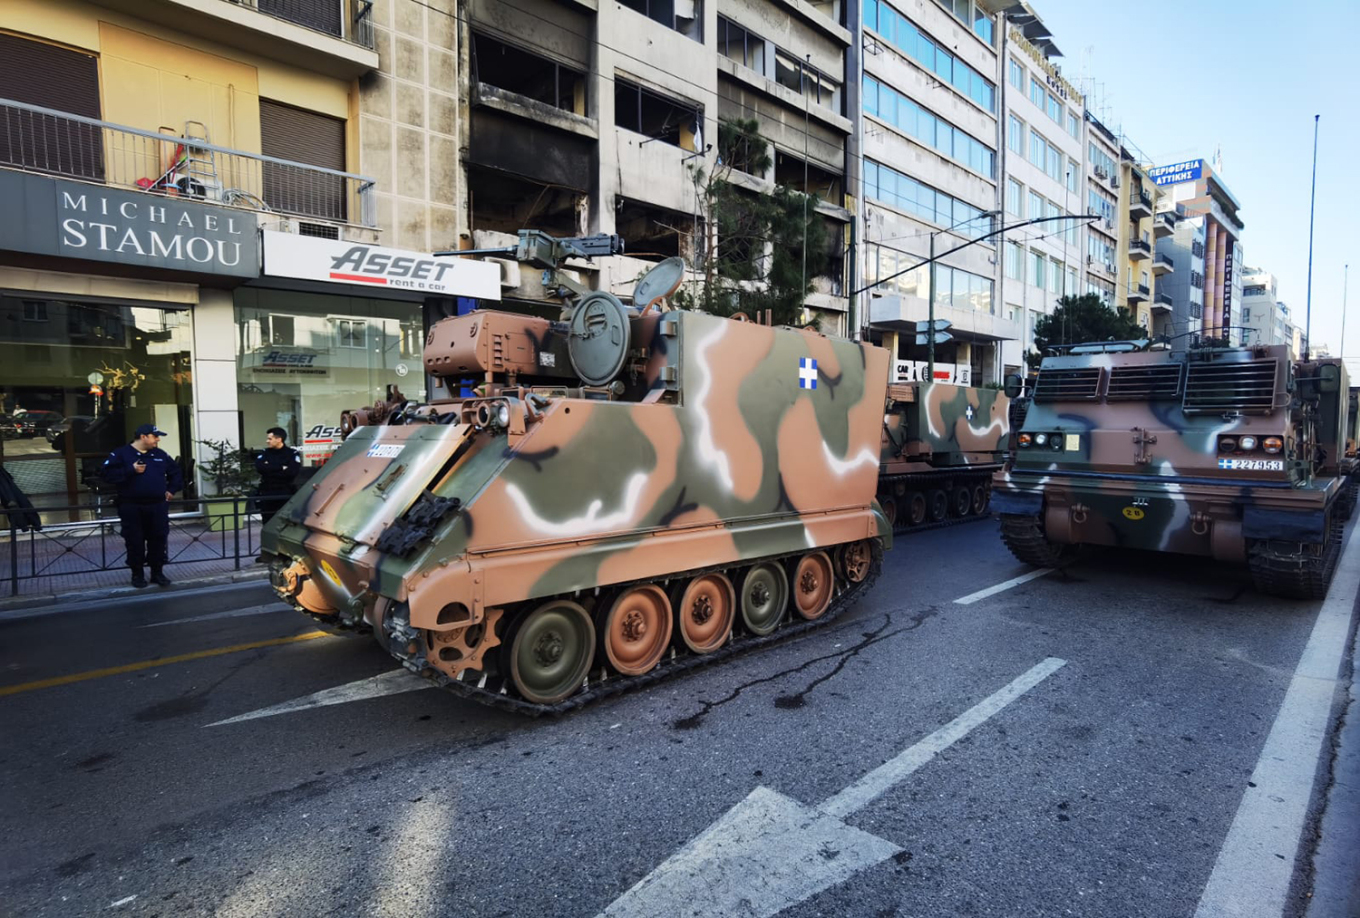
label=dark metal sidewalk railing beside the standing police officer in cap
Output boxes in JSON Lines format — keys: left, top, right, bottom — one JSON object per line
{"left": 0, "top": 496, "right": 260, "bottom": 596}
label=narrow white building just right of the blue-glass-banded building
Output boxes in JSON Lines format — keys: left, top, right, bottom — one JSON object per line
{"left": 1001, "top": 10, "right": 1087, "bottom": 373}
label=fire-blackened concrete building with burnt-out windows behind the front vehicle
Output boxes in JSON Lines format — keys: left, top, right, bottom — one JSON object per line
{"left": 458, "top": 0, "right": 854, "bottom": 335}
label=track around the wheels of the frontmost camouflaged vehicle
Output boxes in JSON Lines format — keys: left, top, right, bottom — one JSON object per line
{"left": 379, "top": 540, "right": 883, "bottom": 717}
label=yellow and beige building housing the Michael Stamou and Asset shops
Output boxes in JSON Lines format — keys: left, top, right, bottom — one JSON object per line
{"left": 0, "top": 0, "right": 499, "bottom": 506}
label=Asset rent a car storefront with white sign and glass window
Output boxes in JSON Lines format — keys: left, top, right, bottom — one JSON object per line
{"left": 234, "top": 230, "right": 500, "bottom": 466}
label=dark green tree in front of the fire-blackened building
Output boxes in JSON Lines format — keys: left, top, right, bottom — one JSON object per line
{"left": 676, "top": 118, "right": 828, "bottom": 325}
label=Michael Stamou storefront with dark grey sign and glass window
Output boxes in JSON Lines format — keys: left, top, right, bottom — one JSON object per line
{"left": 0, "top": 171, "right": 260, "bottom": 518}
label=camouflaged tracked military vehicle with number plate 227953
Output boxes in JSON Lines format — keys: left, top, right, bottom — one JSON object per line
{"left": 993, "top": 341, "right": 1348, "bottom": 598}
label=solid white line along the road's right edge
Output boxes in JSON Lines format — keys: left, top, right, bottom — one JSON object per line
{"left": 1195, "top": 534, "right": 1360, "bottom": 918}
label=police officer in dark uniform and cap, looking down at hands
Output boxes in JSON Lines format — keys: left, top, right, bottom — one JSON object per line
{"left": 102, "top": 424, "right": 184, "bottom": 586}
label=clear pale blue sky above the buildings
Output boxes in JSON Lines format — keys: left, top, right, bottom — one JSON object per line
{"left": 1031, "top": 0, "right": 1360, "bottom": 364}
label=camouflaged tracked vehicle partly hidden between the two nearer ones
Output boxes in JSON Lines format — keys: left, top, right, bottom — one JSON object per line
{"left": 877, "top": 382, "right": 1010, "bottom": 532}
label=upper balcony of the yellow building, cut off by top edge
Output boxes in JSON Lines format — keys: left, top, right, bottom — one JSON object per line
{"left": 95, "top": 0, "right": 378, "bottom": 80}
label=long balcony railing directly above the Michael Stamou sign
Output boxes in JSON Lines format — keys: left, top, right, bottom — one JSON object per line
{"left": 0, "top": 99, "right": 377, "bottom": 226}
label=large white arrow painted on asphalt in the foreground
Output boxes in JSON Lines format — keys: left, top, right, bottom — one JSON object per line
{"left": 600, "top": 657, "right": 1065, "bottom": 918}
